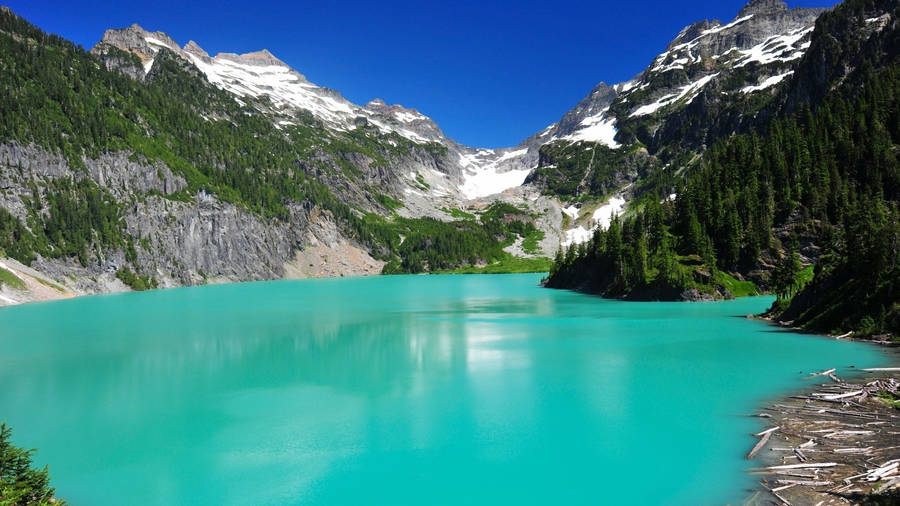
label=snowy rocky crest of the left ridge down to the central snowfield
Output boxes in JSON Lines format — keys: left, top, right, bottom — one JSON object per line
{"left": 92, "top": 25, "right": 539, "bottom": 199}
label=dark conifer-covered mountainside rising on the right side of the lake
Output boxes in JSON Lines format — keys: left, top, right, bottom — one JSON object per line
{"left": 548, "top": 0, "right": 900, "bottom": 336}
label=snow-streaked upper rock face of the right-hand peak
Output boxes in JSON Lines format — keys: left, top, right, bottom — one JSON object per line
{"left": 528, "top": 0, "right": 825, "bottom": 188}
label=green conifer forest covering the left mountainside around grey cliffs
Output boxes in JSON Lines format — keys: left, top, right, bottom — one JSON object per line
{"left": 0, "top": 10, "right": 534, "bottom": 274}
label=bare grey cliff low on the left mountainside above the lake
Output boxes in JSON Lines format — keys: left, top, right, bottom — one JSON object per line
{"left": 0, "top": 140, "right": 364, "bottom": 293}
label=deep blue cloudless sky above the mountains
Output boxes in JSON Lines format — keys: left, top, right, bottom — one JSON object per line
{"left": 8, "top": 0, "right": 834, "bottom": 147}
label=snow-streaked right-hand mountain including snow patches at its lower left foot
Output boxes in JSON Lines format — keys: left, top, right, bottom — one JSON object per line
{"left": 526, "top": 0, "right": 824, "bottom": 245}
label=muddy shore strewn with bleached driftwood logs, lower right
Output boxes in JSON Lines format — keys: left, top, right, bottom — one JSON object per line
{"left": 742, "top": 346, "right": 900, "bottom": 506}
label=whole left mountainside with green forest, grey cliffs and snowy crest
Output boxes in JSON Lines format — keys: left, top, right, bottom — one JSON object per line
{"left": 0, "top": 9, "right": 556, "bottom": 302}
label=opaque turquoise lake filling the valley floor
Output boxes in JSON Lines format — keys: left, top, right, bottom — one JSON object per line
{"left": 0, "top": 275, "right": 888, "bottom": 506}
